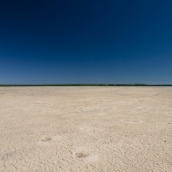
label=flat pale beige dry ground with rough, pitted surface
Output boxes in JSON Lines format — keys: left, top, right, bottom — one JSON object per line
{"left": 0, "top": 87, "right": 172, "bottom": 172}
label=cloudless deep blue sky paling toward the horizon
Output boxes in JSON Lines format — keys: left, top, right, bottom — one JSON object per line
{"left": 0, "top": 0, "right": 172, "bottom": 84}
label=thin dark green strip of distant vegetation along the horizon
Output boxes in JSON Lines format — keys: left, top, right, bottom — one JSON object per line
{"left": 0, "top": 84, "right": 172, "bottom": 87}
